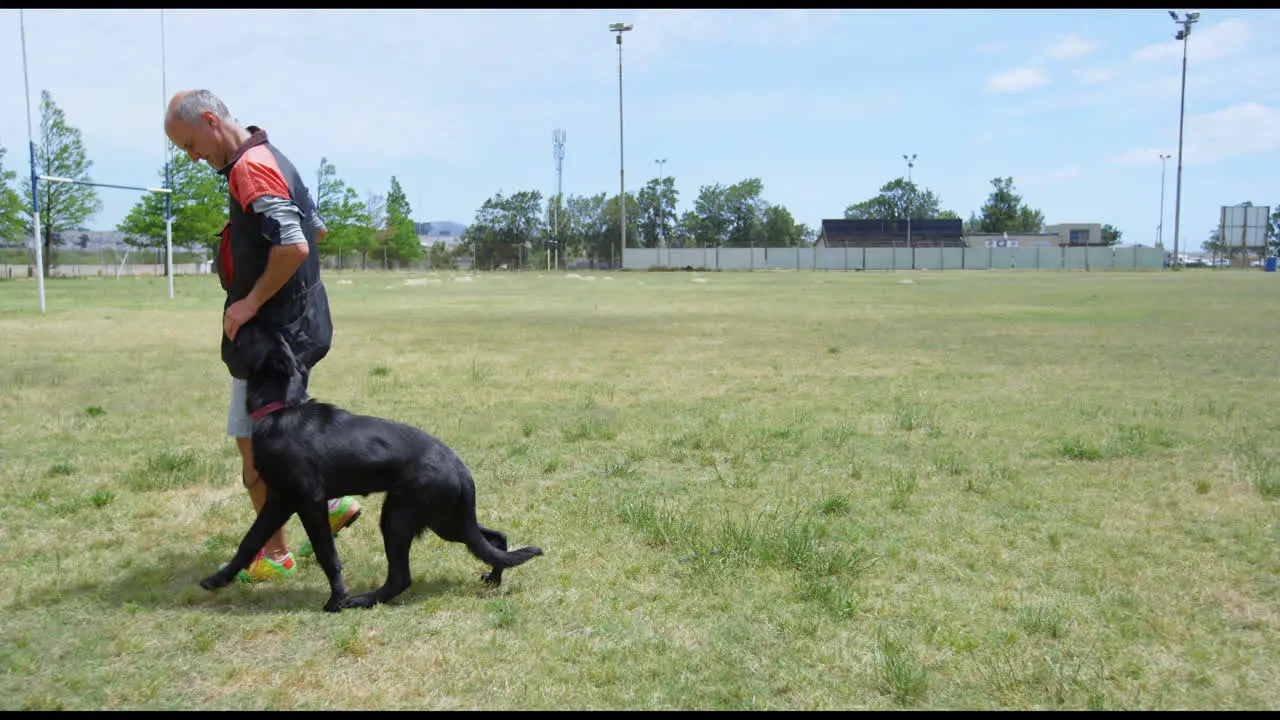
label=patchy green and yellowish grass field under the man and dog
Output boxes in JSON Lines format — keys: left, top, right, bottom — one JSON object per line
{"left": 0, "top": 272, "right": 1280, "bottom": 710}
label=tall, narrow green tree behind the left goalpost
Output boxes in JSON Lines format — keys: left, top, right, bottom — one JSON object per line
{"left": 23, "top": 90, "right": 102, "bottom": 277}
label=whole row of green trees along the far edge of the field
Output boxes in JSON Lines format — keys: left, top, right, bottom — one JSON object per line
{"left": 0, "top": 90, "right": 1280, "bottom": 274}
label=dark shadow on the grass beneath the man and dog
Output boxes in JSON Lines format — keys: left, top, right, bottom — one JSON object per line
{"left": 15, "top": 551, "right": 498, "bottom": 615}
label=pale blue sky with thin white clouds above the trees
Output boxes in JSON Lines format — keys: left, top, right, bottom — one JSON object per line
{"left": 0, "top": 9, "right": 1280, "bottom": 250}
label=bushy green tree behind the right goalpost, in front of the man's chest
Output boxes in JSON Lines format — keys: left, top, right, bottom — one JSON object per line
{"left": 115, "top": 152, "right": 228, "bottom": 260}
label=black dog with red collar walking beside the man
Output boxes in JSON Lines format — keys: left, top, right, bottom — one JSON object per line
{"left": 200, "top": 322, "right": 543, "bottom": 612}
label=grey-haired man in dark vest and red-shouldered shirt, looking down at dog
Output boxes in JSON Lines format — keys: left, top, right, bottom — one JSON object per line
{"left": 164, "top": 90, "right": 360, "bottom": 582}
